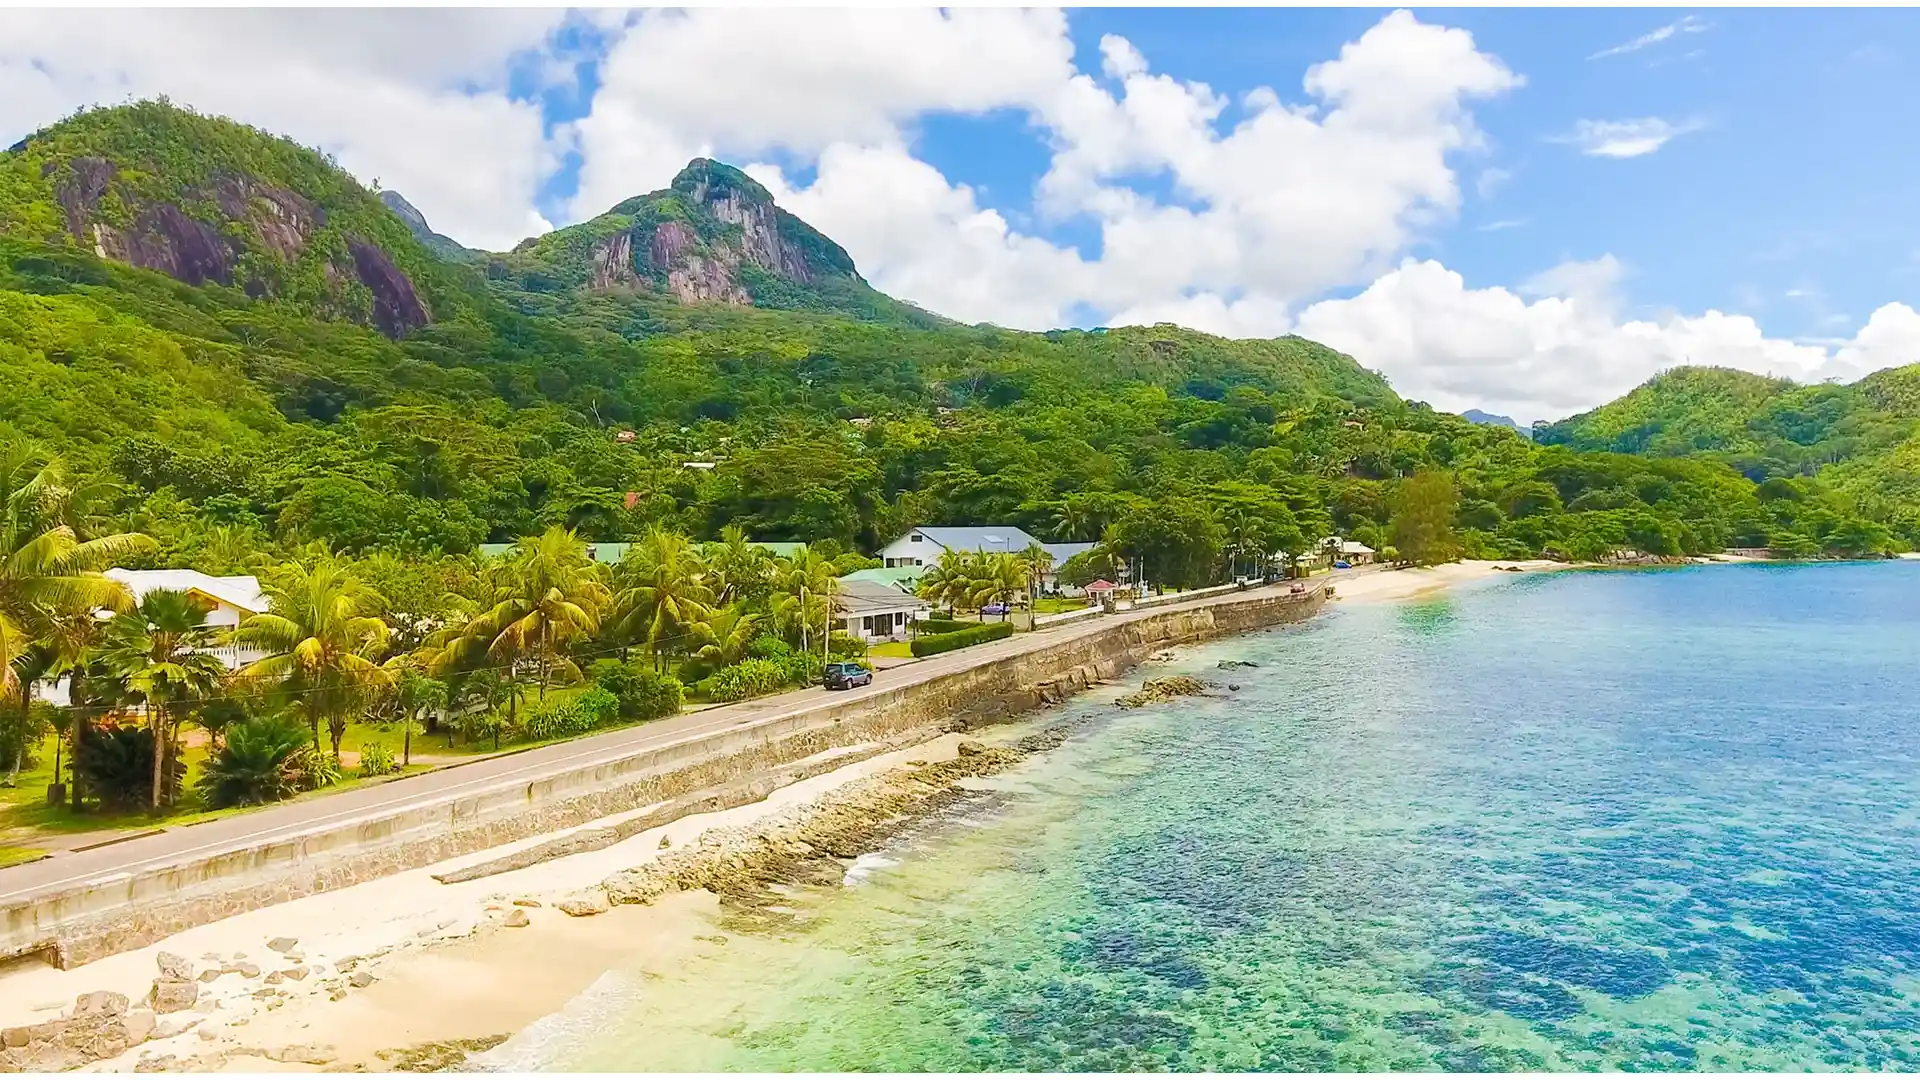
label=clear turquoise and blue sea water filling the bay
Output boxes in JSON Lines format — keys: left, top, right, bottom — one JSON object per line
{"left": 533, "top": 563, "right": 1920, "bottom": 1070}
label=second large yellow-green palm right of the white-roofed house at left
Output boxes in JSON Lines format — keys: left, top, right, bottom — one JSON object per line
{"left": 467, "top": 525, "right": 611, "bottom": 691}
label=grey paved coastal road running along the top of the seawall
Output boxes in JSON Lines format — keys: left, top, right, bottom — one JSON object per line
{"left": 0, "top": 586, "right": 1313, "bottom": 905}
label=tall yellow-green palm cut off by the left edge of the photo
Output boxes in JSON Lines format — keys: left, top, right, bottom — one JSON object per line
{"left": 0, "top": 444, "right": 154, "bottom": 709}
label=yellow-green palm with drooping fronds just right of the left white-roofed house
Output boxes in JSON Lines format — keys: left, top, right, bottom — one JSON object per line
{"left": 232, "top": 555, "right": 392, "bottom": 757}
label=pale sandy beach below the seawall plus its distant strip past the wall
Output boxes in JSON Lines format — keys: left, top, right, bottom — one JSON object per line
{"left": 0, "top": 561, "right": 1561, "bottom": 1072}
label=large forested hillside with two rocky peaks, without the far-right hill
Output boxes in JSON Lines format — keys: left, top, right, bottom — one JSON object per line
{"left": 0, "top": 104, "right": 1920, "bottom": 577}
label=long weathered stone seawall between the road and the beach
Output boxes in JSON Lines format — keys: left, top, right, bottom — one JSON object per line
{"left": 0, "top": 590, "right": 1325, "bottom": 967}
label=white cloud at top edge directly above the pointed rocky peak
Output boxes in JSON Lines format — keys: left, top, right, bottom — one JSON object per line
{"left": 572, "top": 8, "right": 1073, "bottom": 217}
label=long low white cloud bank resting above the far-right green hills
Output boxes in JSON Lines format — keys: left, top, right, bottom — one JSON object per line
{"left": 1296, "top": 256, "right": 1920, "bottom": 423}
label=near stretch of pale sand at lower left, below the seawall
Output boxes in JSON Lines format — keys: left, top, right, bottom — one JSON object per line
{"left": 0, "top": 736, "right": 960, "bottom": 1070}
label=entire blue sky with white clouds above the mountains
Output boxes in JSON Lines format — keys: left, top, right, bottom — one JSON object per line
{"left": 0, "top": 8, "right": 1920, "bottom": 419}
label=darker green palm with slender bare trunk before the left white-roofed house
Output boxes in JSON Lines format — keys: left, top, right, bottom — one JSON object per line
{"left": 100, "top": 588, "right": 227, "bottom": 811}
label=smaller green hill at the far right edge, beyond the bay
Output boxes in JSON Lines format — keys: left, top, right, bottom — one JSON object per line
{"left": 1534, "top": 365, "right": 1920, "bottom": 513}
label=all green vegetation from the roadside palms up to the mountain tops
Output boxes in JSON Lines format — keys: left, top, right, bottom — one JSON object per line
{"left": 0, "top": 104, "right": 1920, "bottom": 822}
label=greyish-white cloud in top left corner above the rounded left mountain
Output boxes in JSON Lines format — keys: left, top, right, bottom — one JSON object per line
{"left": 0, "top": 8, "right": 564, "bottom": 248}
